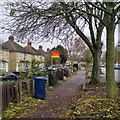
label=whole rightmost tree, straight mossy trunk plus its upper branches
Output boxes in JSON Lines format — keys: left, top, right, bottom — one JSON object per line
{"left": 86, "top": 2, "right": 120, "bottom": 98}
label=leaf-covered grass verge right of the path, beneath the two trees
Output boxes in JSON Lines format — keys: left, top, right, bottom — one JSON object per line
{"left": 65, "top": 83, "right": 120, "bottom": 119}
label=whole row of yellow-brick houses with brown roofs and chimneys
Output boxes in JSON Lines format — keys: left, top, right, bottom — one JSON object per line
{"left": 0, "top": 36, "right": 46, "bottom": 72}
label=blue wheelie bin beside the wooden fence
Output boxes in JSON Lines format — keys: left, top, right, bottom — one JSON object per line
{"left": 33, "top": 77, "right": 47, "bottom": 100}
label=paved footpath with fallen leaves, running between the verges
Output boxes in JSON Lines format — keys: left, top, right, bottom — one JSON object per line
{"left": 28, "top": 70, "right": 87, "bottom": 118}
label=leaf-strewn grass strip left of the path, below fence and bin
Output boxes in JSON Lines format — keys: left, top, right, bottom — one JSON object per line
{"left": 2, "top": 95, "right": 47, "bottom": 119}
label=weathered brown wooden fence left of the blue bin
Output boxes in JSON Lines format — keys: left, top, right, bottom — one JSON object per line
{"left": 2, "top": 80, "right": 34, "bottom": 110}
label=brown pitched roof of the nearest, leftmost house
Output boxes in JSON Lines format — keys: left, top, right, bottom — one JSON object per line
{"left": 2, "top": 40, "right": 25, "bottom": 52}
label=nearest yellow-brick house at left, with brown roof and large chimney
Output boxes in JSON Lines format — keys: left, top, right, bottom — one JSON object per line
{"left": 2, "top": 36, "right": 30, "bottom": 72}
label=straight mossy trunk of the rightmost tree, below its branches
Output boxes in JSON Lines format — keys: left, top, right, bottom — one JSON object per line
{"left": 106, "top": 20, "right": 116, "bottom": 98}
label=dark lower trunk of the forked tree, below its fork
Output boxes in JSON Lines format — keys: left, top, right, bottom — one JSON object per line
{"left": 89, "top": 50, "right": 101, "bottom": 85}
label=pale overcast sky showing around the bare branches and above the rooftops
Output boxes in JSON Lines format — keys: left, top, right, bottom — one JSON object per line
{"left": 0, "top": 0, "right": 118, "bottom": 51}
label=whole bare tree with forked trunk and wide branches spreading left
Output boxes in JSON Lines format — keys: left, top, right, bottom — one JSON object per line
{"left": 1, "top": 1, "right": 105, "bottom": 84}
